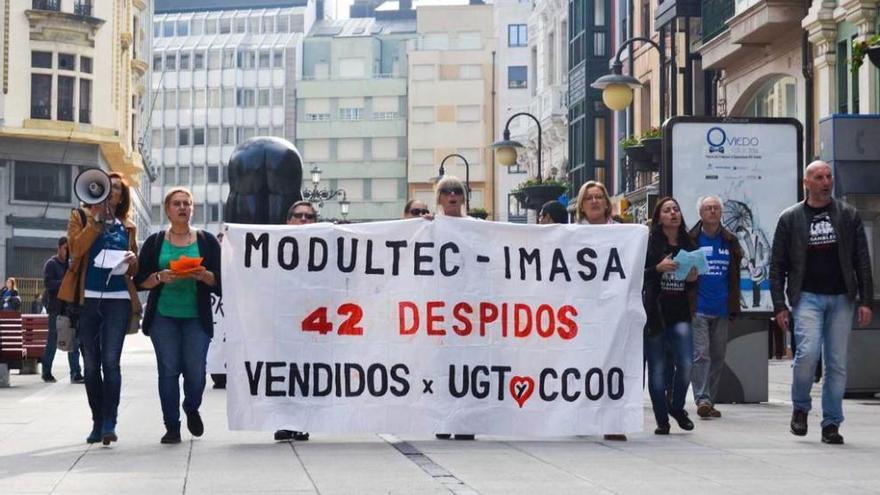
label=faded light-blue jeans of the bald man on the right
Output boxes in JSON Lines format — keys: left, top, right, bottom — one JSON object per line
{"left": 791, "top": 292, "right": 855, "bottom": 427}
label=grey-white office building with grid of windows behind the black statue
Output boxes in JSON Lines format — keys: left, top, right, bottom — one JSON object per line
{"left": 150, "top": 0, "right": 316, "bottom": 232}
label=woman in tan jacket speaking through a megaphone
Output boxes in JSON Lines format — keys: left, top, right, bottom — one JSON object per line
{"left": 58, "top": 169, "right": 141, "bottom": 445}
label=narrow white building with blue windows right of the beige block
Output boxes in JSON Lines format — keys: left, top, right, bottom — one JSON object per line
{"left": 491, "top": 0, "right": 534, "bottom": 223}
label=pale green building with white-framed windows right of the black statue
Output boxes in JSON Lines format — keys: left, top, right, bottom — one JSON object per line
{"left": 296, "top": 10, "right": 416, "bottom": 221}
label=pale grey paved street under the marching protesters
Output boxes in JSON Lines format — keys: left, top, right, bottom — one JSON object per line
{"left": 0, "top": 335, "right": 880, "bottom": 495}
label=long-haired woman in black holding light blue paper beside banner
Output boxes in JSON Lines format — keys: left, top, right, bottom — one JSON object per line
{"left": 643, "top": 197, "right": 697, "bottom": 435}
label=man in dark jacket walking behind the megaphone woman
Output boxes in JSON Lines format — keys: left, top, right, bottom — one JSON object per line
{"left": 42, "top": 237, "right": 85, "bottom": 383}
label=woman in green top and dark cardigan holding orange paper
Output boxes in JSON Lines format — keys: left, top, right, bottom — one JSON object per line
{"left": 136, "top": 187, "right": 220, "bottom": 443}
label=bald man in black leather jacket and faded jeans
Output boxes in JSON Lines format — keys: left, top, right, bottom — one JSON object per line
{"left": 770, "top": 161, "right": 874, "bottom": 444}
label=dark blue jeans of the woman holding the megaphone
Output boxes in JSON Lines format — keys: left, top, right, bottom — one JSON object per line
{"left": 76, "top": 298, "right": 131, "bottom": 426}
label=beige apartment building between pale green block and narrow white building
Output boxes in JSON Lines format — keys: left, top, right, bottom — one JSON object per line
{"left": 407, "top": 0, "right": 496, "bottom": 218}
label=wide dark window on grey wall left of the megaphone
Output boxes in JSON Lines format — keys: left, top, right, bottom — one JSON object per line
{"left": 13, "top": 161, "right": 73, "bottom": 203}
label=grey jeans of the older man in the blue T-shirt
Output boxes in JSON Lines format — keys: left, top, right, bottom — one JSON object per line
{"left": 692, "top": 313, "right": 728, "bottom": 406}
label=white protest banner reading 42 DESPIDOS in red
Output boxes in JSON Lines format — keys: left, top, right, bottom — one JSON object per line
{"left": 222, "top": 217, "right": 648, "bottom": 436}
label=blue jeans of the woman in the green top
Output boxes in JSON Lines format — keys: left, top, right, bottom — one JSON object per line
{"left": 150, "top": 314, "right": 211, "bottom": 426}
